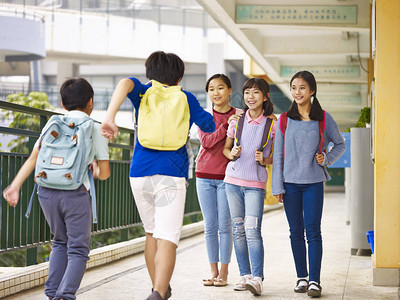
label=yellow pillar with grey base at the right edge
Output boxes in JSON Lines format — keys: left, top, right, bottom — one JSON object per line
{"left": 373, "top": 0, "right": 400, "bottom": 286}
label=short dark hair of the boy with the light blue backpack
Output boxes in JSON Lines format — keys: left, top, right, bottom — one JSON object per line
{"left": 60, "top": 78, "right": 94, "bottom": 110}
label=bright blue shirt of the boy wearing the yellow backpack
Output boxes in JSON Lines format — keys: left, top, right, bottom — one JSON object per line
{"left": 128, "top": 77, "right": 215, "bottom": 179}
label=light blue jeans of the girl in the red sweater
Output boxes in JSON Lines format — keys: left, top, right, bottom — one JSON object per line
{"left": 196, "top": 178, "right": 232, "bottom": 264}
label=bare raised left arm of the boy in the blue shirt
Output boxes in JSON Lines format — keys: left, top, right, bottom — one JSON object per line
{"left": 101, "top": 78, "right": 135, "bottom": 141}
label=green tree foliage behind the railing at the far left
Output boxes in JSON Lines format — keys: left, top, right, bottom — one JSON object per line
{"left": 1, "top": 92, "right": 54, "bottom": 153}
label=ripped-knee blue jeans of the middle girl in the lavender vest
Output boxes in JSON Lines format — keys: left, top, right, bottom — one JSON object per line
{"left": 225, "top": 183, "right": 265, "bottom": 278}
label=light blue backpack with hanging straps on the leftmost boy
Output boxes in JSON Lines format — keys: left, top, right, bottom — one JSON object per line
{"left": 25, "top": 115, "right": 97, "bottom": 223}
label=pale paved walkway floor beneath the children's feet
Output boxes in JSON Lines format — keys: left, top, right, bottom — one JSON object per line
{"left": 6, "top": 193, "right": 399, "bottom": 300}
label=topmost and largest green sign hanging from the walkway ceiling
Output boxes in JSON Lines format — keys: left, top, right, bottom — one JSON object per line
{"left": 236, "top": 5, "right": 357, "bottom": 24}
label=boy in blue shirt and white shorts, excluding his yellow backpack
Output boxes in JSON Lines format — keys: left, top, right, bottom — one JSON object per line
{"left": 101, "top": 51, "right": 215, "bottom": 300}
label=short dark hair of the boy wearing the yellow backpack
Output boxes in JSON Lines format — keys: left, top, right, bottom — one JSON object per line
{"left": 144, "top": 51, "right": 185, "bottom": 85}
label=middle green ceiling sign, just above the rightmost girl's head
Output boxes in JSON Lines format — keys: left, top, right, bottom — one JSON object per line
{"left": 281, "top": 66, "right": 360, "bottom": 80}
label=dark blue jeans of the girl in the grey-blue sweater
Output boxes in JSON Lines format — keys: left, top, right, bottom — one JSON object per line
{"left": 283, "top": 182, "right": 324, "bottom": 283}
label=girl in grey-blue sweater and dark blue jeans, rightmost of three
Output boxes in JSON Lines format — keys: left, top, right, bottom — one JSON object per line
{"left": 272, "top": 71, "right": 346, "bottom": 297}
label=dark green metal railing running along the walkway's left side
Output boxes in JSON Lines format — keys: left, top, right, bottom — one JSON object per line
{"left": 0, "top": 101, "right": 200, "bottom": 265}
